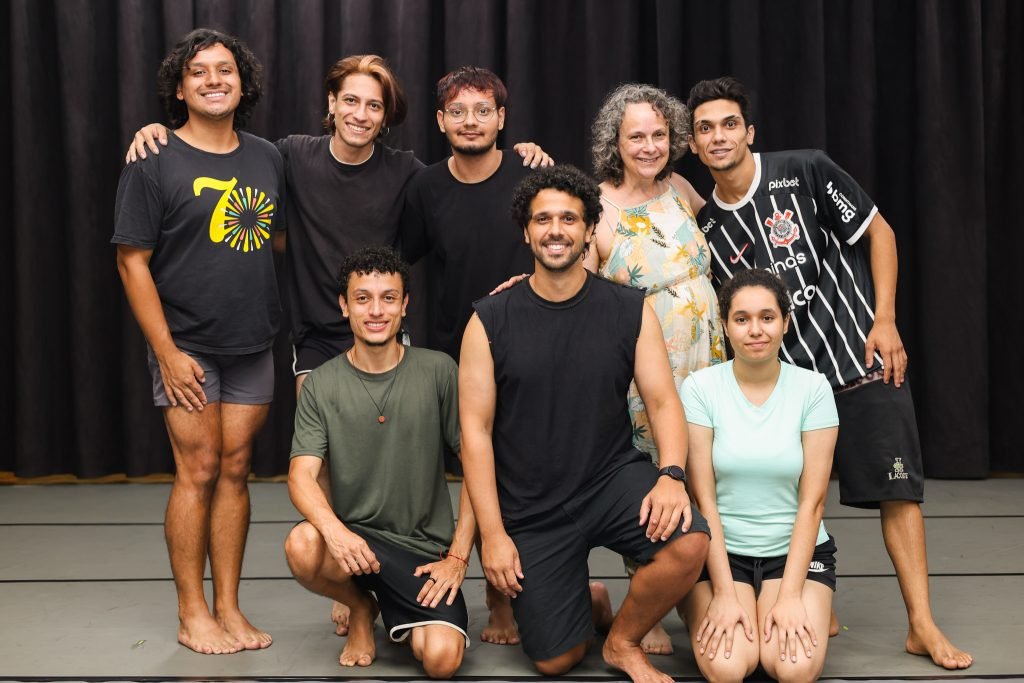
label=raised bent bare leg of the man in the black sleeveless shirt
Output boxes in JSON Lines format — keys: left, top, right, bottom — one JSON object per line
{"left": 603, "top": 532, "right": 708, "bottom": 683}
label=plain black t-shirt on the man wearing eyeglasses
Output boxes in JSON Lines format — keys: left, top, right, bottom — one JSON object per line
{"left": 401, "top": 152, "right": 534, "bottom": 360}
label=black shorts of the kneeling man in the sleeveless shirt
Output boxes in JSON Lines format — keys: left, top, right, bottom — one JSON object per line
{"left": 506, "top": 462, "right": 711, "bottom": 661}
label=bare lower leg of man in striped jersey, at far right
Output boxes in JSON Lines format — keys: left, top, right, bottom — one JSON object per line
{"left": 881, "top": 501, "right": 974, "bottom": 669}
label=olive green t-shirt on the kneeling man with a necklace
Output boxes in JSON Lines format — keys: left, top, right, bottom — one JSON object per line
{"left": 291, "top": 347, "right": 460, "bottom": 557}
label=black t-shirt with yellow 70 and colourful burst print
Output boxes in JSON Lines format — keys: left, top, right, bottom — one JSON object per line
{"left": 111, "top": 131, "right": 285, "bottom": 355}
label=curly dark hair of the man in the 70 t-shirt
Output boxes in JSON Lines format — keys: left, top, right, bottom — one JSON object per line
{"left": 157, "top": 29, "right": 263, "bottom": 130}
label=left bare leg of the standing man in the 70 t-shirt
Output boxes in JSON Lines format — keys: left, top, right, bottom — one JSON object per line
{"left": 164, "top": 402, "right": 243, "bottom": 654}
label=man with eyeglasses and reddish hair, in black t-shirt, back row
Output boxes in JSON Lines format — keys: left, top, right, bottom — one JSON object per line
{"left": 401, "top": 67, "right": 553, "bottom": 645}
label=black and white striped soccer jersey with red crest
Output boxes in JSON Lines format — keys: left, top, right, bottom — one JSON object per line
{"left": 697, "top": 150, "right": 882, "bottom": 387}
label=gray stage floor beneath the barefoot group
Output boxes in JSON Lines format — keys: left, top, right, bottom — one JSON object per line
{"left": 0, "top": 479, "right": 1024, "bottom": 680}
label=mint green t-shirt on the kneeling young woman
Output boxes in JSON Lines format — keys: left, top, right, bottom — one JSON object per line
{"left": 682, "top": 360, "right": 839, "bottom": 557}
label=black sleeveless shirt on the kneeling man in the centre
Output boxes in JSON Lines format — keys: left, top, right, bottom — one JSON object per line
{"left": 473, "top": 273, "right": 644, "bottom": 524}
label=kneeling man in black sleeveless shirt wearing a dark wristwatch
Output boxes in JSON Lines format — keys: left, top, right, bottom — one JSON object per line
{"left": 459, "top": 166, "right": 709, "bottom": 681}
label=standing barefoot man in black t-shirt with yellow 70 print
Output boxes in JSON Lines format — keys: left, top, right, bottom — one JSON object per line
{"left": 112, "top": 29, "right": 285, "bottom": 654}
